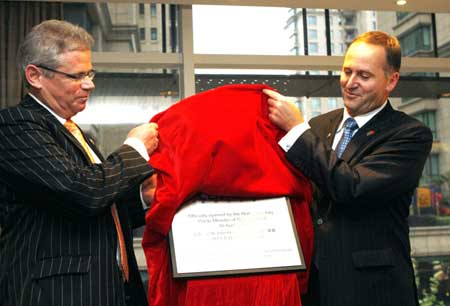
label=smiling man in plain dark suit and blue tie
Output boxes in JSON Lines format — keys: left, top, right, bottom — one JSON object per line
{"left": 266, "top": 31, "right": 432, "bottom": 306}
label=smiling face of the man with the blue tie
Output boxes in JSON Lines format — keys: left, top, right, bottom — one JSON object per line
{"left": 340, "top": 42, "right": 399, "bottom": 117}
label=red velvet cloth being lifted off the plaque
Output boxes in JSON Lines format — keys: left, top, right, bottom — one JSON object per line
{"left": 142, "top": 85, "right": 313, "bottom": 306}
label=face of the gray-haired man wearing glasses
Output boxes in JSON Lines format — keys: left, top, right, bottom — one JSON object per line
{"left": 39, "top": 50, "right": 95, "bottom": 118}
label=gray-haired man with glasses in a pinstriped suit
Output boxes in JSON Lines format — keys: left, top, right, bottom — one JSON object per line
{"left": 0, "top": 20, "right": 158, "bottom": 306}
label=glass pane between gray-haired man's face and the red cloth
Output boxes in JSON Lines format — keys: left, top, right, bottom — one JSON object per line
{"left": 74, "top": 71, "right": 180, "bottom": 156}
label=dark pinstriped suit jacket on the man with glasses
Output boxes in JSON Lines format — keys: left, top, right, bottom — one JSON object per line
{"left": 0, "top": 96, "right": 153, "bottom": 306}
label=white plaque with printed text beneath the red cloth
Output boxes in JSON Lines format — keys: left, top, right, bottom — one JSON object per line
{"left": 169, "top": 197, "right": 306, "bottom": 278}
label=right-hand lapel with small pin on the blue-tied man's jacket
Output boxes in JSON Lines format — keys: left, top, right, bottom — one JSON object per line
{"left": 342, "top": 102, "right": 394, "bottom": 161}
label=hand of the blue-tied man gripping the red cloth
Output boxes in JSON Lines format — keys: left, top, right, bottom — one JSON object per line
{"left": 263, "top": 89, "right": 304, "bottom": 132}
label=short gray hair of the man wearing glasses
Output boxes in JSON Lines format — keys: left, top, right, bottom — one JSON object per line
{"left": 18, "top": 20, "right": 94, "bottom": 82}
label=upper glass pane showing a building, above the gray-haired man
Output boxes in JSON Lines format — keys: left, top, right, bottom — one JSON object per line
{"left": 63, "top": 1, "right": 179, "bottom": 53}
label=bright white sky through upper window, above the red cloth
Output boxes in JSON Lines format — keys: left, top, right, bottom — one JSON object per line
{"left": 193, "top": 5, "right": 292, "bottom": 55}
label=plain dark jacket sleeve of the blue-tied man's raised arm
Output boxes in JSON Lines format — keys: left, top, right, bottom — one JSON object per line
{"left": 286, "top": 121, "right": 432, "bottom": 206}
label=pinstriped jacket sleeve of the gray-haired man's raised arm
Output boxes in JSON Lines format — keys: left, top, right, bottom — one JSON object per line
{"left": 0, "top": 112, "right": 152, "bottom": 216}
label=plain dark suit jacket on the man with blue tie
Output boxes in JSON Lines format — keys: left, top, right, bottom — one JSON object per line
{"left": 287, "top": 103, "right": 432, "bottom": 306}
